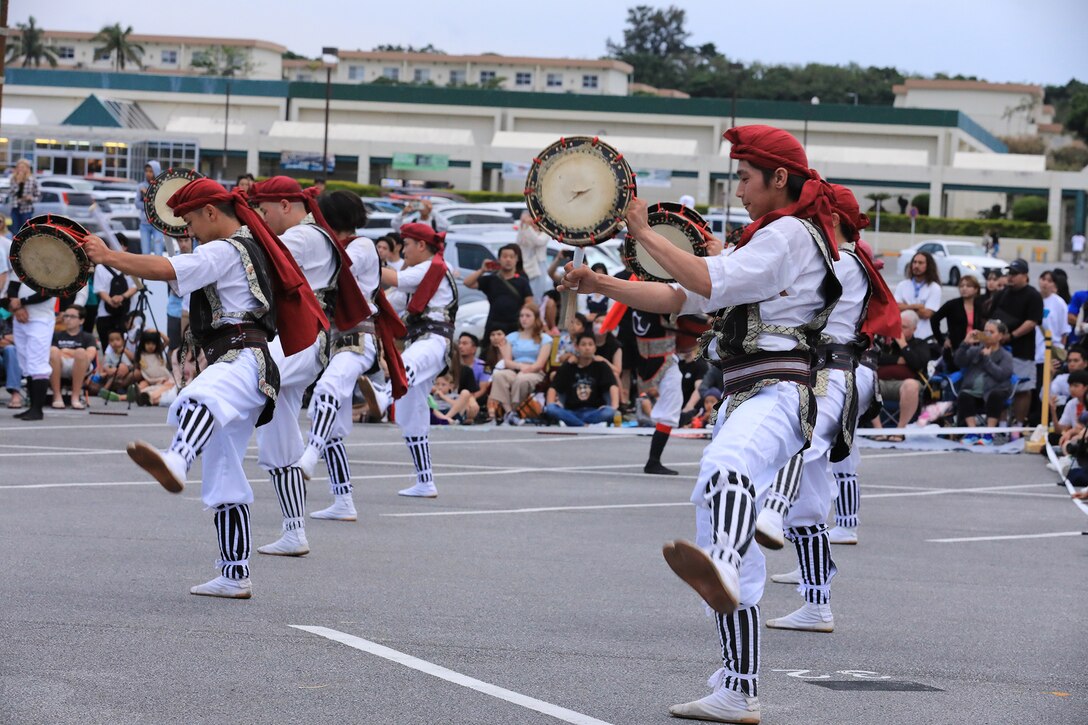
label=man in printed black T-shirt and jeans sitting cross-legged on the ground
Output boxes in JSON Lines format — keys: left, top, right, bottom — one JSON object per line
{"left": 544, "top": 332, "right": 619, "bottom": 428}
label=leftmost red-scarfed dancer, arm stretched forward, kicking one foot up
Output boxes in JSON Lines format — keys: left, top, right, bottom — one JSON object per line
{"left": 85, "top": 179, "right": 327, "bottom": 599}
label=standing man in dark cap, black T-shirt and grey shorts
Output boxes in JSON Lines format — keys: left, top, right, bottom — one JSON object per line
{"left": 990, "top": 259, "right": 1042, "bottom": 423}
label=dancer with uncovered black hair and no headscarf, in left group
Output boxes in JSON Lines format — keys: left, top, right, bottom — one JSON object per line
{"left": 297, "top": 192, "right": 407, "bottom": 521}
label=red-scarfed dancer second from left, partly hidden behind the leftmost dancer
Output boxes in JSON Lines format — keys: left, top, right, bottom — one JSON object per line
{"left": 248, "top": 176, "right": 370, "bottom": 556}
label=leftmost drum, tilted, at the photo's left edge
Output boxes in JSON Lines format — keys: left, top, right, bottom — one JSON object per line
{"left": 9, "top": 214, "right": 95, "bottom": 297}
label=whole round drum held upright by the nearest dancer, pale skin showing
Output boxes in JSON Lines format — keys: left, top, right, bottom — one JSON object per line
{"left": 526, "top": 136, "right": 635, "bottom": 246}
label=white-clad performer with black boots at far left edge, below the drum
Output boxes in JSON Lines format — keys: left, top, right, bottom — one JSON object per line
{"left": 3, "top": 277, "right": 57, "bottom": 420}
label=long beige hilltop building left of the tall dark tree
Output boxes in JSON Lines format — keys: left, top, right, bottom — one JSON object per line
{"left": 283, "top": 50, "right": 634, "bottom": 96}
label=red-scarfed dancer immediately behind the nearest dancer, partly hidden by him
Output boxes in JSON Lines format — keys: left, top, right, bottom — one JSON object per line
{"left": 755, "top": 185, "right": 898, "bottom": 632}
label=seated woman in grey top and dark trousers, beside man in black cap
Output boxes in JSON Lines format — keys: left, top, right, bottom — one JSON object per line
{"left": 955, "top": 320, "right": 1013, "bottom": 435}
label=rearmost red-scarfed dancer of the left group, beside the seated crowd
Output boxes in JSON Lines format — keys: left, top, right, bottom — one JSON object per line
{"left": 382, "top": 222, "right": 457, "bottom": 499}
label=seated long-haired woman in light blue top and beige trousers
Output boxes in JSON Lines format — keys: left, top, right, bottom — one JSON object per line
{"left": 487, "top": 303, "right": 552, "bottom": 421}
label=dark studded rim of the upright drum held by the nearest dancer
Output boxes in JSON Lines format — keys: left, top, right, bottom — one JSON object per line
{"left": 524, "top": 136, "right": 638, "bottom": 247}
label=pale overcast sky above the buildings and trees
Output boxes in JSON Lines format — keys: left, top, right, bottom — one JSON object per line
{"left": 17, "top": 0, "right": 1088, "bottom": 85}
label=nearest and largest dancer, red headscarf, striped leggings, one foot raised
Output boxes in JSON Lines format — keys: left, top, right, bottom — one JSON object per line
{"left": 564, "top": 125, "right": 841, "bottom": 723}
